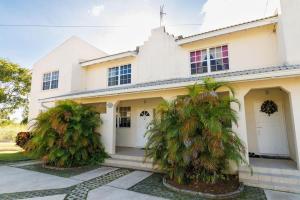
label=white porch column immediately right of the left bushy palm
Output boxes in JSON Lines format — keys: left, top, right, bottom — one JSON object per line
{"left": 100, "top": 102, "right": 117, "bottom": 154}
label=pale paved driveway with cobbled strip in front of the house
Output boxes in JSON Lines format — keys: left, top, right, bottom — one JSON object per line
{"left": 0, "top": 162, "right": 300, "bottom": 200}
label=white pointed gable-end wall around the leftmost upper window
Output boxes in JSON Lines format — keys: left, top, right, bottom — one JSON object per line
{"left": 29, "top": 36, "right": 105, "bottom": 119}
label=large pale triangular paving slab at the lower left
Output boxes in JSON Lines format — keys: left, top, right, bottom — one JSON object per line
{"left": 0, "top": 166, "right": 81, "bottom": 194}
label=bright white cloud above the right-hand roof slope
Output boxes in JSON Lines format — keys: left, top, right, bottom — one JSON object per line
{"left": 201, "top": 0, "right": 279, "bottom": 31}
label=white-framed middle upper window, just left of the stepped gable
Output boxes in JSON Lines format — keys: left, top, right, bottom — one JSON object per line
{"left": 108, "top": 64, "right": 131, "bottom": 86}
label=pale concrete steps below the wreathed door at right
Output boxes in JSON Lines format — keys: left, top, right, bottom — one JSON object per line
{"left": 239, "top": 167, "right": 300, "bottom": 193}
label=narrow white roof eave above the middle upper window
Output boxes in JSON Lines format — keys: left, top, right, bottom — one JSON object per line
{"left": 80, "top": 51, "right": 137, "bottom": 67}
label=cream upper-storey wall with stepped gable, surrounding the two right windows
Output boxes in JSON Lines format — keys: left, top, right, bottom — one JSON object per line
{"left": 85, "top": 25, "right": 282, "bottom": 90}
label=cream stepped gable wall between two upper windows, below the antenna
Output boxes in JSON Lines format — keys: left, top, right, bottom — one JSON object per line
{"left": 133, "top": 27, "right": 190, "bottom": 83}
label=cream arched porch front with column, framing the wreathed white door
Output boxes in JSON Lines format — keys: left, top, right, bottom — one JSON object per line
{"left": 232, "top": 79, "right": 300, "bottom": 169}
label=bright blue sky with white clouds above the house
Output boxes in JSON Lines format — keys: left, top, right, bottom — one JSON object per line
{"left": 0, "top": 0, "right": 279, "bottom": 68}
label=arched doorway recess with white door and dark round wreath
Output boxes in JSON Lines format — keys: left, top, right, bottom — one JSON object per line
{"left": 245, "top": 87, "right": 296, "bottom": 161}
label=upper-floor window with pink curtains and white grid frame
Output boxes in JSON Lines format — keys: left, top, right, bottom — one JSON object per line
{"left": 190, "top": 45, "right": 229, "bottom": 74}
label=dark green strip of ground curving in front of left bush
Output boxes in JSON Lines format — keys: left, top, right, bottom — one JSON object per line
{"left": 19, "top": 164, "right": 101, "bottom": 177}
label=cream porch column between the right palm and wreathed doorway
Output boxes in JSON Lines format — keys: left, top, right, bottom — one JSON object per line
{"left": 231, "top": 89, "right": 249, "bottom": 163}
